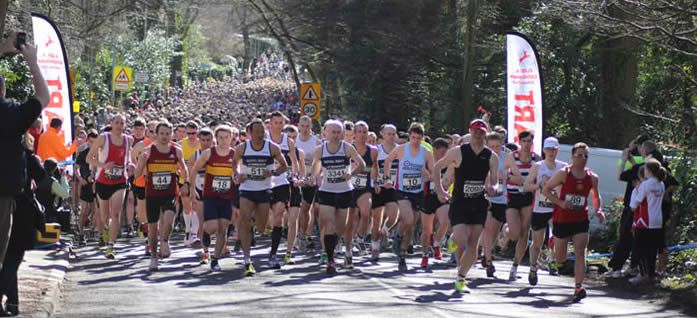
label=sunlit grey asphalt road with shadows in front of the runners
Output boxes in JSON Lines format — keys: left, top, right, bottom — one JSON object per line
{"left": 56, "top": 235, "right": 682, "bottom": 318}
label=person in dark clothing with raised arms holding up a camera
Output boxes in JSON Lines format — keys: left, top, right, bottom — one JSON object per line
{"left": 0, "top": 33, "right": 49, "bottom": 270}
